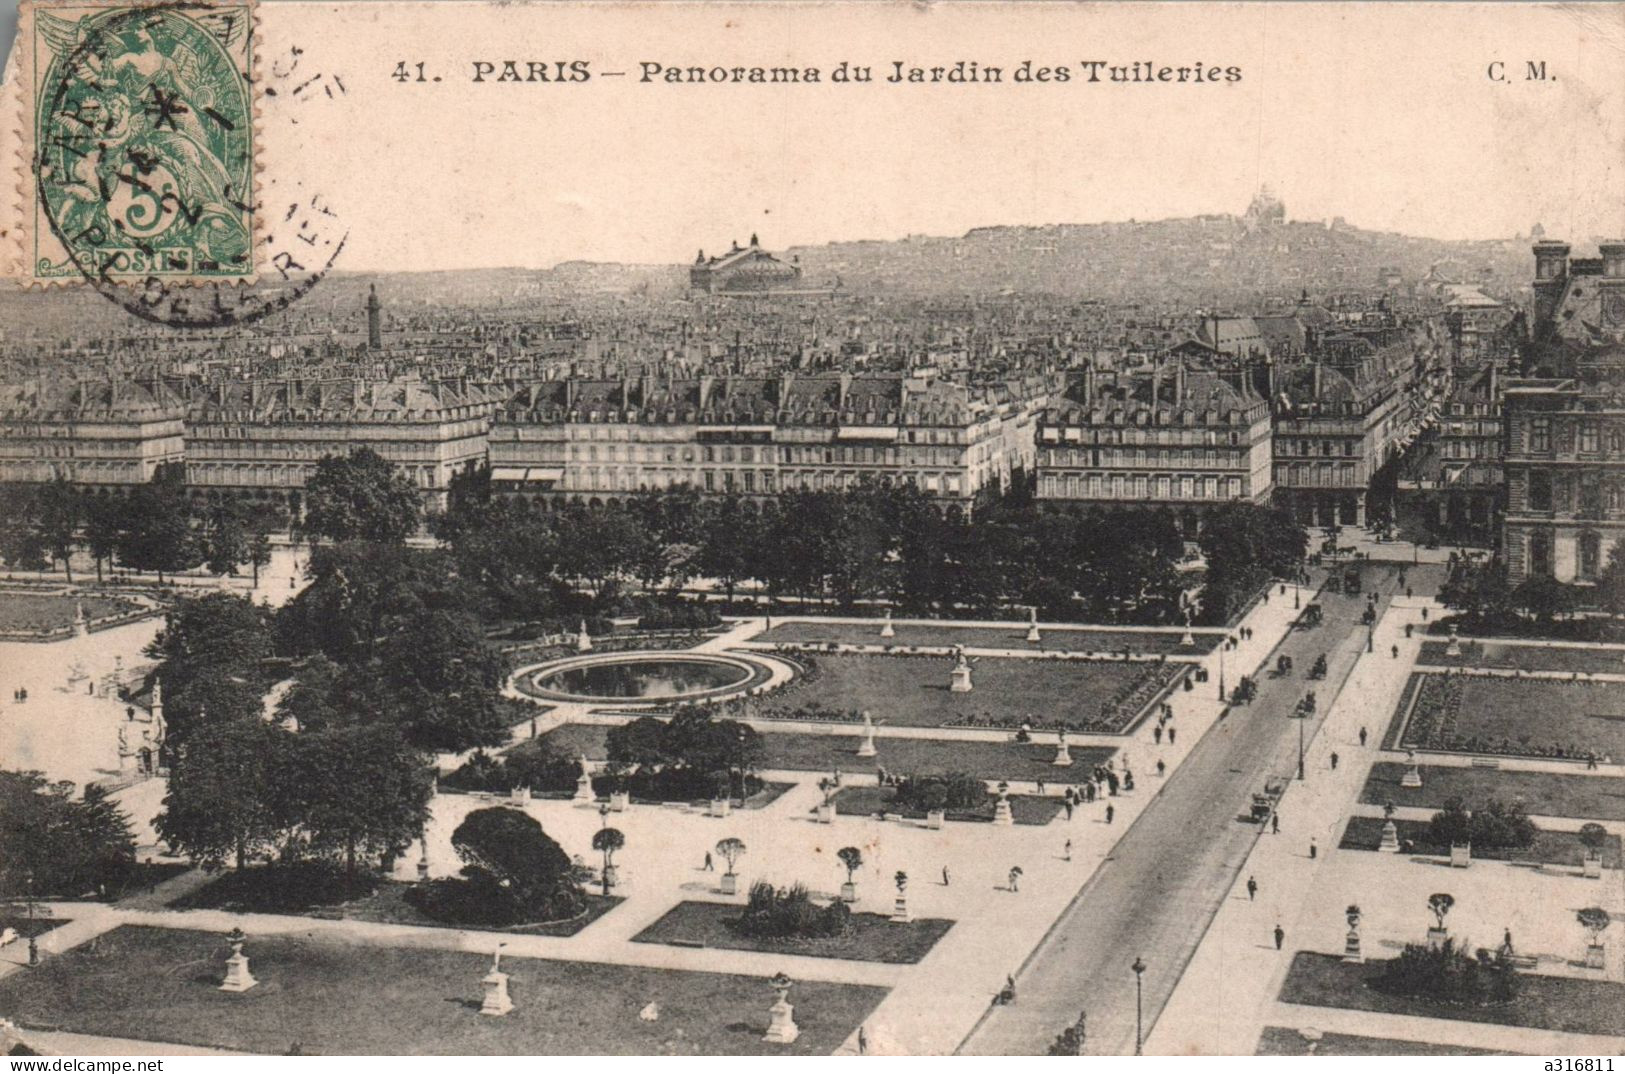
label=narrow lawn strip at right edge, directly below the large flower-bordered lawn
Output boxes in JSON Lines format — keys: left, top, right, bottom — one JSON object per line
{"left": 1360, "top": 762, "right": 1625, "bottom": 821}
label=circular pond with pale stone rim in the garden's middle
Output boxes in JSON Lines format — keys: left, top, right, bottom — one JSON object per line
{"left": 525, "top": 653, "right": 769, "bottom": 704}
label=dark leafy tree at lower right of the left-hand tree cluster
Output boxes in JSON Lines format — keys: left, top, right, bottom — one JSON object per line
{"left": 294, "top": 723, "right": 432, "bottom": 886}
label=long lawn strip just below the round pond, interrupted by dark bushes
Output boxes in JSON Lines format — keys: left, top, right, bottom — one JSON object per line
{"left": 533, "top": 723, "right": 1116, "bottom": 783}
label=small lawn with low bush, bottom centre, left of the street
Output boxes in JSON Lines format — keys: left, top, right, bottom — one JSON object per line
{"left": 632, "top": 902, "right": 954, "bottom": 962}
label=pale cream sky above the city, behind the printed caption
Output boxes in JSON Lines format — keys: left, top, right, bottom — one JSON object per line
{"left": 15, "top": 0, "right": 1625, "bottom": 271}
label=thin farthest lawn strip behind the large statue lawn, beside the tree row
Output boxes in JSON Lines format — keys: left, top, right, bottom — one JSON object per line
{"left": 751, "top": 619, "right": 1224, "bottom": 656}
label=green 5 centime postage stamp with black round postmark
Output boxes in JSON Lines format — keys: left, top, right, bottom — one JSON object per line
{"left": 18, "top": 0, "right": 257, "bottom": 288}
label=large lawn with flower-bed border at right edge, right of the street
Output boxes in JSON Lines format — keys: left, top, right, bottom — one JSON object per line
{"left": 1394, "top": 674, "right": 1625, "bottom": 760}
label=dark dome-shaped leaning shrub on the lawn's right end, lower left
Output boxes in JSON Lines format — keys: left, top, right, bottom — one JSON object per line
{"left": 452, "top": 806, "right": 585, "bottom": 920}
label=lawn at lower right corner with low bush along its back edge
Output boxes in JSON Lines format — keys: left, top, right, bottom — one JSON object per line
{"left": 1281, "top": 951, "right": 1625, "bottom": 1037}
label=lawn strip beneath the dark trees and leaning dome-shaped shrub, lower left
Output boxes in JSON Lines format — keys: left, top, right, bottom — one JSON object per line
{"left": 171, "top": 864, "right": 621, "bottom": 936}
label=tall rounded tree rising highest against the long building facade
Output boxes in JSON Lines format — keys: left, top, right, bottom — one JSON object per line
{"left": 302, "top": 448, "right": 423, "bottom": 544}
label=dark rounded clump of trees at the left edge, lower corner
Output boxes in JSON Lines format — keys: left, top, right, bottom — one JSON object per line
{"left": 0, "top": 772, "right": 135, "bottom": 899}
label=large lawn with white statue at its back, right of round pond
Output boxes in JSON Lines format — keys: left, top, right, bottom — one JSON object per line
{"left": 751, "top": 653, "right": 1191, "bottom": 734}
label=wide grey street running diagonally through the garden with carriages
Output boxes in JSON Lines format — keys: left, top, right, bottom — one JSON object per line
{"left": 959, "top": 565, "right": 1430, "bottom": 1055}
